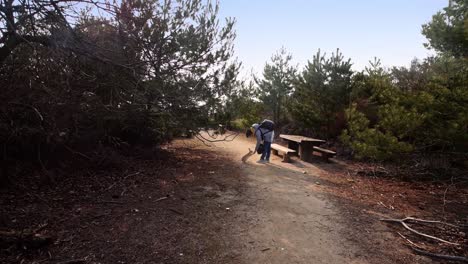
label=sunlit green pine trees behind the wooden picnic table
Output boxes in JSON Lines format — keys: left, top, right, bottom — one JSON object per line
{"left": 225, "top": 1, "right": 468, "bottom": 167}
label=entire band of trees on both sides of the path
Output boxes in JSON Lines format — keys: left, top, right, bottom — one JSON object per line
{"left": 0, "top": 0, "right": 468, "bottom": 184}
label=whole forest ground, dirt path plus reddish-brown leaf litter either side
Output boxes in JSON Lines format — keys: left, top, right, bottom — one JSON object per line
{"left": 0, "top": 135, "right": 468, "bottom": 264}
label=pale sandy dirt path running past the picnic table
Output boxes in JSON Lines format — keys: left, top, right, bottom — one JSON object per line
{"left": 198, "top": 138, "right": 436, "bottom": 263}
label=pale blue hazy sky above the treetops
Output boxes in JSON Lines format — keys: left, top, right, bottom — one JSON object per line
{"left": 220, "top": 0, "right": 448, "bottom": 76}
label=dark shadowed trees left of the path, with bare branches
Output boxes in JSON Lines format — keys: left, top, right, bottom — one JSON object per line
{"left": 0, "top": 0, "right": 239, "bottom": 186}
